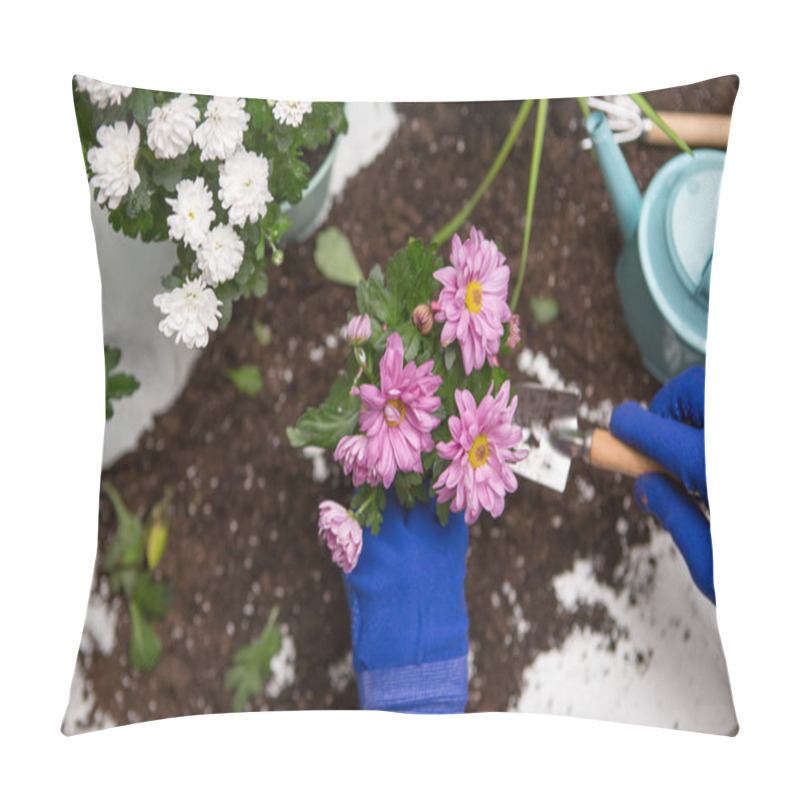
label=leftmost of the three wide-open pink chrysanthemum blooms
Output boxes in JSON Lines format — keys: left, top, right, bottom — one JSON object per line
{"left": 353, "top": 333, "right": 442, "bottom": 489}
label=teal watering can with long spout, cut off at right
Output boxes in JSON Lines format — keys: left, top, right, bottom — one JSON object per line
{"left": 586, "top": 111, "right": 725, "bottom": 383}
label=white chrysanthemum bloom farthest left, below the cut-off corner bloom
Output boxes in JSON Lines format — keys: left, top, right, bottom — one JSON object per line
{"left": 86, "top": 120, "right": 140, "bottom": 208}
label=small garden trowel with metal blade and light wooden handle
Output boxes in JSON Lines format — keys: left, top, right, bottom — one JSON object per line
{"left": 512, "top": 383, "right": 664, "bottom": 492}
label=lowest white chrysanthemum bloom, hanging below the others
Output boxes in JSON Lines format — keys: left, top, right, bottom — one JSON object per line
{"left": 153, "top": 278, "right": 222, "bottom": 350}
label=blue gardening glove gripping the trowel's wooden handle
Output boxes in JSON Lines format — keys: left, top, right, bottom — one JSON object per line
{"left": 610, "top": 367, "right": 716, "bottom": 603}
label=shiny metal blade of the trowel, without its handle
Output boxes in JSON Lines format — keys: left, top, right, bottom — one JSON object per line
{"left": 512, "top": 383, "right": 580, "bottom": 492}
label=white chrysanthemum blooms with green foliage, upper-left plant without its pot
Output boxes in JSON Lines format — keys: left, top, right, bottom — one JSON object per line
{"left": 73, "top": 76, "right": 347, "bottom": 348}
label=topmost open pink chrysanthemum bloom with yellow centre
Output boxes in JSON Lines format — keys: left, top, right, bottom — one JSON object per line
{"left": 433, "top": 228, "right": 511, "bottom": 375}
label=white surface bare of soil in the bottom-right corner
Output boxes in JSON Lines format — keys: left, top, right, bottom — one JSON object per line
{"left": 514, "top": 524, "right": 737, "bottom": 734}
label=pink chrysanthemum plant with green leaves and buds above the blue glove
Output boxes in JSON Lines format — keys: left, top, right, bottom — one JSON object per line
{"left": 287, "top": 228, "right": 526, "bottom": 572}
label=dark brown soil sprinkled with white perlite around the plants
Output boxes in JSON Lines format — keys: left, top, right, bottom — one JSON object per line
{"left": 65, "top": 77, "right": 738, "bottom": 724}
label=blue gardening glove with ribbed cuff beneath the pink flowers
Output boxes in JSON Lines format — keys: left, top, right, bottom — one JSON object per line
{"left": 344, "top": 492, "right": 469, "bottom": 714}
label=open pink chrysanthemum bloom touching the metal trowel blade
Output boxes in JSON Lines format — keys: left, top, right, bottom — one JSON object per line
{"left": 433, "top": 381, "right": 527, "bottom": 525}
